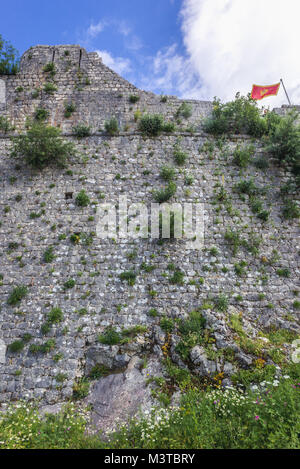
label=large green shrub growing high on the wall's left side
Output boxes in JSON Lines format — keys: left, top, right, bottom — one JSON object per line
{"left": 11, "top": 123, "right": 75, "bottom": 168}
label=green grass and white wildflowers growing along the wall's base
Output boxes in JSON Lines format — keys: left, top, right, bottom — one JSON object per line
{"left": 0, "top": 364, "right": 300, "bottom": 450}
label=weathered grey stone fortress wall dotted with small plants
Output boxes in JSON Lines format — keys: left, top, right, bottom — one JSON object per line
{"left": 0, "top": 45, "right": 300, "bottom": 404}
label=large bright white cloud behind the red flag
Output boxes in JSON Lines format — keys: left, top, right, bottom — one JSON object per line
{"left": 181, "top": 0, "right": 300, "bottom": 107}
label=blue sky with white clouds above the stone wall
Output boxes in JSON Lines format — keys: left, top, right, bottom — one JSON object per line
{"left": 0, "top": 0, "right": 300, "bottom": 107}
